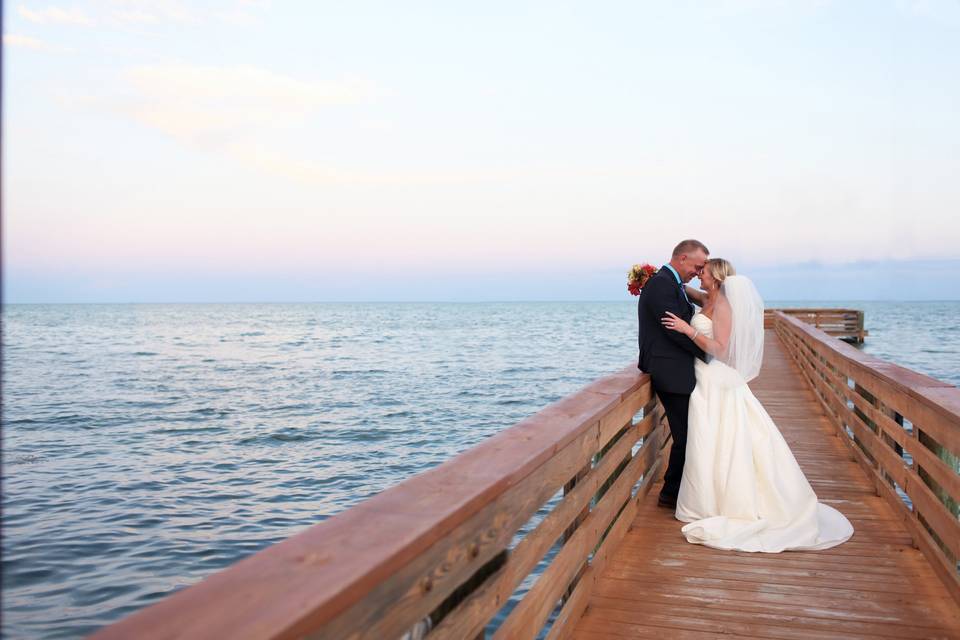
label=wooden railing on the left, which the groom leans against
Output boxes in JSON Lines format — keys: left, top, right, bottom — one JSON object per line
{"left": 94, "top": 367, "right": 668, "bottom": 640}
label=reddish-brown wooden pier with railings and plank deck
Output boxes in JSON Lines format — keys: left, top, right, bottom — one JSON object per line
{"left": 95, "top": 312, "right": 960, "bottom": 640}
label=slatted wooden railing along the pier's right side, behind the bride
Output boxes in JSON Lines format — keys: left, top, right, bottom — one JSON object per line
{"left": 773, "top": 312, "right": 960, "bottom": 602}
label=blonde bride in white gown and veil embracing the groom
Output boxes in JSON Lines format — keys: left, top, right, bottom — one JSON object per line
{"left": 662, "top": 258, "right": 853, "bottom": 553}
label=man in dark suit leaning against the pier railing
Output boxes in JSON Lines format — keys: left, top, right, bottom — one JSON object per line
{"left": 637, "top": 240, "right": 710, "bottom": 509}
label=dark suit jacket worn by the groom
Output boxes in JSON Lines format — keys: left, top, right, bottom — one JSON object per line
{"left": 637, "top": 266, "right": 704, "bottom": 393}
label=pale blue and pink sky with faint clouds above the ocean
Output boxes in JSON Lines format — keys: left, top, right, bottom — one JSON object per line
{"left": 2, "top": 0, "right": 960, "bottom": 303}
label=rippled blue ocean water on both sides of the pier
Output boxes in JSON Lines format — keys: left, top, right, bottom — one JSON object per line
{"left": 2, "top": 301, "right": 960, "bottom": 638}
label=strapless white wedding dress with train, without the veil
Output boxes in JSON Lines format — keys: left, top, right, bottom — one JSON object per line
{"left": 676, "top": 313, "right": 853, "bottom": 553}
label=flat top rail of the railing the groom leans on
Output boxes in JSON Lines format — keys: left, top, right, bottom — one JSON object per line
{"left": 94, "top": 365, "right": 649, "bottom": 638}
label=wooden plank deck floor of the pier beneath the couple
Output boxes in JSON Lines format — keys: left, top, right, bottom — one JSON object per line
{"left": 571, "top": 330, "right": 960, "bottom": 640}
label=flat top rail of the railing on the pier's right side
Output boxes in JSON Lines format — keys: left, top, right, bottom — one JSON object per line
{"left": 775, "top": 310, "right": 960, "bottom": 427}
